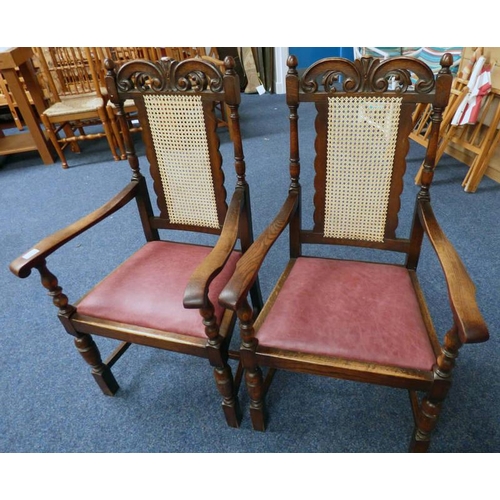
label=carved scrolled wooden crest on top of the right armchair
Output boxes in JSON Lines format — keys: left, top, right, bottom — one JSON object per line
{"left": 296, "top": 57, "right": 438, "bottom": 94}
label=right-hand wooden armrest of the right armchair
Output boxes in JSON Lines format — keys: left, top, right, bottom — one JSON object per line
{"left": 419, "top": 201, "right": 489, "bottom": 343}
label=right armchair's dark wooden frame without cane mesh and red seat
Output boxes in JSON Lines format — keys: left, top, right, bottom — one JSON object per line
{"left": 220, "top": 54, "right": 488, "bottom": 451}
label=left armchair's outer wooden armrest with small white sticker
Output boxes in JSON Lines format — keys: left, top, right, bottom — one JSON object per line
{"left": 9, "top": 181, "right": 138, "bottom": 278}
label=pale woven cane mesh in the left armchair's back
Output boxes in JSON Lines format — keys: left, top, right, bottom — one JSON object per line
{"left": 144, "top": 95, "right": 219, "bottom": 228}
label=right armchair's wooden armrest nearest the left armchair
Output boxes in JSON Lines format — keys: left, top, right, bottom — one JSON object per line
{"left": 219, "top": 191, "right": 299, "bottom": 310}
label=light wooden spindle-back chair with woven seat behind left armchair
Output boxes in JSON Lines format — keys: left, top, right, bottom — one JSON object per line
{"left": 33, "top": 47, "right": 120, "bottom": 168}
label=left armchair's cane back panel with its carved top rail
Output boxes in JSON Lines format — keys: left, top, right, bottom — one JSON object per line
{"left": 110, "top": 58, "right": 231, "bottom": 232}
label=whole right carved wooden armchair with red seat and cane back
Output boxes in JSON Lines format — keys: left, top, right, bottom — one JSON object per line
{"left": 220, "top": 55, "right": 488, "bottom": 451}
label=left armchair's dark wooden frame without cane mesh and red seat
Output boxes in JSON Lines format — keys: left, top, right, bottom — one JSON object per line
{"left": 10, "top": 58, "right": 262, "bottom": 427}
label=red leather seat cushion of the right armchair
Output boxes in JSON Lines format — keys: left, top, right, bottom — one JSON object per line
{"left": 257, "top": 257, "right": 436, "bottom": 370}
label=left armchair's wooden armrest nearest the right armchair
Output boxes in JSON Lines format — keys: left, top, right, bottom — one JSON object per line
{"left": 183, "top": 188, "right": 245, "bottom": 309}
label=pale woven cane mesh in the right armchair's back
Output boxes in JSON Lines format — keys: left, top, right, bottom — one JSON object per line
{"left": 324, "top": 97, "right": 402, "bottom": 242}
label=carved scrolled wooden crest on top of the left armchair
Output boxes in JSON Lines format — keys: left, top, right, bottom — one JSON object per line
{"left": 116, "top": 57, "right": 223, "bottom": 93}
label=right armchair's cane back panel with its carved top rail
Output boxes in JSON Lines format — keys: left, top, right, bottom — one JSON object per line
{"left": 289, "top": 57, "right": 442, "bottom": 243}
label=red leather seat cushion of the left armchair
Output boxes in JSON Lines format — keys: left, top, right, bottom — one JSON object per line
{"left": 78, "top": 241, "right": 240, "bottom": 337}
